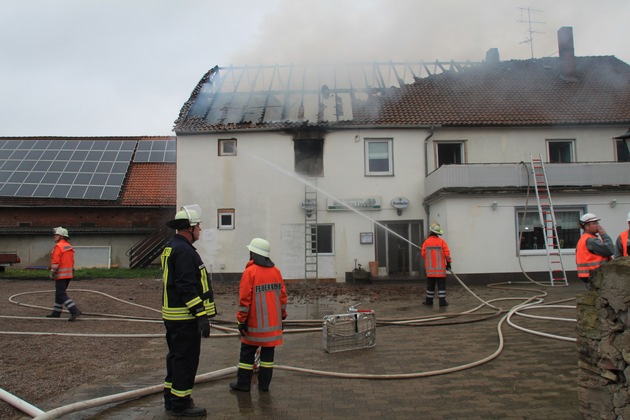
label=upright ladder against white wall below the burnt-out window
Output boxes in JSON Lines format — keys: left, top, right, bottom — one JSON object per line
{"left": 304, "top": 178, "right": 319, "bottom": 284}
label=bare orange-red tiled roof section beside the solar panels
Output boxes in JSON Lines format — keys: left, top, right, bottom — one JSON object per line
{"left": 119, "top": 163, "right": 177, "bottom": 206}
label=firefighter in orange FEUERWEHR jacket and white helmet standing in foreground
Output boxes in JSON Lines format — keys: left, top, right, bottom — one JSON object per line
{"left": 230, "top": 238, "right": 287, "bottom": 392}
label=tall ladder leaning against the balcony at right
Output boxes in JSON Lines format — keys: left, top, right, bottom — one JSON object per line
{"left": 530, "top": 155, "right": 569, "bottom": 286}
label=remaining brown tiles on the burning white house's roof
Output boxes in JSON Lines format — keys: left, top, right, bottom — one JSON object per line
{"left": 175, "top": 56, "right": 630, "bottom": 133}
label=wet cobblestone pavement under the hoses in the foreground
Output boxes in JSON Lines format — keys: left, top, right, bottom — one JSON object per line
{"left": 58, "top": 278, "right": 583, "bottom": 420}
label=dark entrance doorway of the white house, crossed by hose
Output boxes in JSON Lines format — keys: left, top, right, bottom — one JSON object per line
{"left": 375, "top": 221, "right": 422, "bottom": 278}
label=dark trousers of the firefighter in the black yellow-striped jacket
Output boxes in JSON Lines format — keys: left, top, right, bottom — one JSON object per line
{"left": 164, "top": 319, "right": 201, "bottom": 410}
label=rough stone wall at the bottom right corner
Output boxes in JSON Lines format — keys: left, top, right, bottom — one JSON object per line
{"left": 577, "top": 257, "right": 630, "bottom": 419}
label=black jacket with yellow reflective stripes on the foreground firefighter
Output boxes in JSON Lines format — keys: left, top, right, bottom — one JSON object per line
{"left": 160, "top": 235, "right": 216, "bottom": 321}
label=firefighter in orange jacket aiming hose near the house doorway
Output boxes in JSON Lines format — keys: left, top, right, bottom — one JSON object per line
{"left": 421, "top": 222, "right": 451, "bottom": 306}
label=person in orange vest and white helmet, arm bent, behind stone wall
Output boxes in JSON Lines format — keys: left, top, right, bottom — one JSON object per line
{"left": 575, "top": 213, "right": 615, "bottom": 290}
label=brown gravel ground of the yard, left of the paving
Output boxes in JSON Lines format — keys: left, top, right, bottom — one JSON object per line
{"left": 0, "top": 279, "right": 423, "bottom": 419}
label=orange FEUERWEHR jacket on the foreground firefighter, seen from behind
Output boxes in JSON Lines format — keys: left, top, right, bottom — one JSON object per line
{"left": 236, "top": 260, "right": 287, "bottom": 347}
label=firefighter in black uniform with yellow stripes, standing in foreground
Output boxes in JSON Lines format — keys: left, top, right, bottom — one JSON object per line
{"left": 160, "top": 205, "right": 216, "bottom": 417}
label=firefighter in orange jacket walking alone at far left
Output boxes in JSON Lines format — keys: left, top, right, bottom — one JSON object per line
{"left": 46, "top": 226, "right": 81, "bottom": 322}
